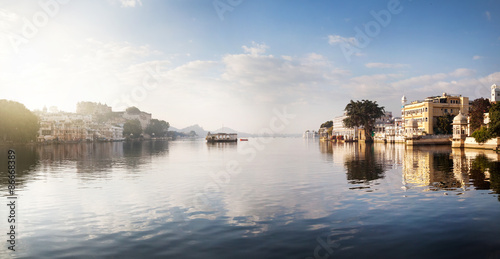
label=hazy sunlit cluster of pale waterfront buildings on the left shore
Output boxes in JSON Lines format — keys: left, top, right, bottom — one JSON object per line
{"left": 34, "top": 102, "right": 151, "bottom": 143}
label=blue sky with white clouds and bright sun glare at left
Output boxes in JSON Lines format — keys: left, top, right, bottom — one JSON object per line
{"left": 0, "top": 0, "right": 500, "bottom": 133}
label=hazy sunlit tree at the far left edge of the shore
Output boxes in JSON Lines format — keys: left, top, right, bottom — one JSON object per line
{"left": 0, "top": 99, "right": 40, "bottom": 143}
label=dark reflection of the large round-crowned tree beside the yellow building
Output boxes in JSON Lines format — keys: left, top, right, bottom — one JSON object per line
{"left": 344, "top": 144, "right": 386, "bottom": 184}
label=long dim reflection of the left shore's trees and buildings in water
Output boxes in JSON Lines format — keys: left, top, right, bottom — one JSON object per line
{"left": 0, "top": 141, "right": 168, "bottom": 189}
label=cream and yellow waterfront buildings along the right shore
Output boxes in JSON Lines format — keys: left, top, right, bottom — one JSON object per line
{"left": 318, "top": 84, "right": 500, "bottom": 149}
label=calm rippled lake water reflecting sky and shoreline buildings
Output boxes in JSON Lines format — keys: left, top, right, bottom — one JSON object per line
{"left": 0, "top": 138, "right": 500, "bottom": 258}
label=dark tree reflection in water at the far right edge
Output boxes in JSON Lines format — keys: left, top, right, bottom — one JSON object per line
{"left": 470, "top": 155, "right": 500, "bottom": 201}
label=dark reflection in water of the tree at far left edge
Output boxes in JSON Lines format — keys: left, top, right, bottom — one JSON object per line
{"left": 0, "top": 145, "right": 38, "bottom": 195}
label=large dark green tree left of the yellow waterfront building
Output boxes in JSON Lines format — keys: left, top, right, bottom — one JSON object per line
{"left": 343, "top": 100, "right": 384, "bottom": 141}
